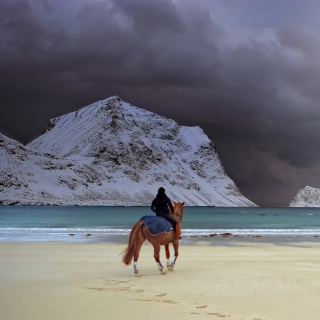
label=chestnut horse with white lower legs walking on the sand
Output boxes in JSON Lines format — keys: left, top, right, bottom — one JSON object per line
{"left": 122, "top": 202, "right": 184, "bottom": 277}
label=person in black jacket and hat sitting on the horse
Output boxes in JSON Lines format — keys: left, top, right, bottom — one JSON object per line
{"left": 151, "top": 187, "right": 182, "bottom": 239}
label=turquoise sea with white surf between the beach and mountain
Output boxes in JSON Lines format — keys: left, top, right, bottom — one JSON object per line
{"left": 0, "top": 206, "right": 320, "bottom": 241}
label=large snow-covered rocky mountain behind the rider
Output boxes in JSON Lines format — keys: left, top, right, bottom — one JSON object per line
{"left": 0, "top": 97, "right": 255, "bottom": 206}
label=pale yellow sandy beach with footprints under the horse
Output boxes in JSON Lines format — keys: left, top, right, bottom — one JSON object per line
{"left": 0, "top": 242, "right": 320, "bottom": 320}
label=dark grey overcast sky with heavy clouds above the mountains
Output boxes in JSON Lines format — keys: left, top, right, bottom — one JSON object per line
{"left": 0, "top": 0, "right": 320, "bottom": 206}
